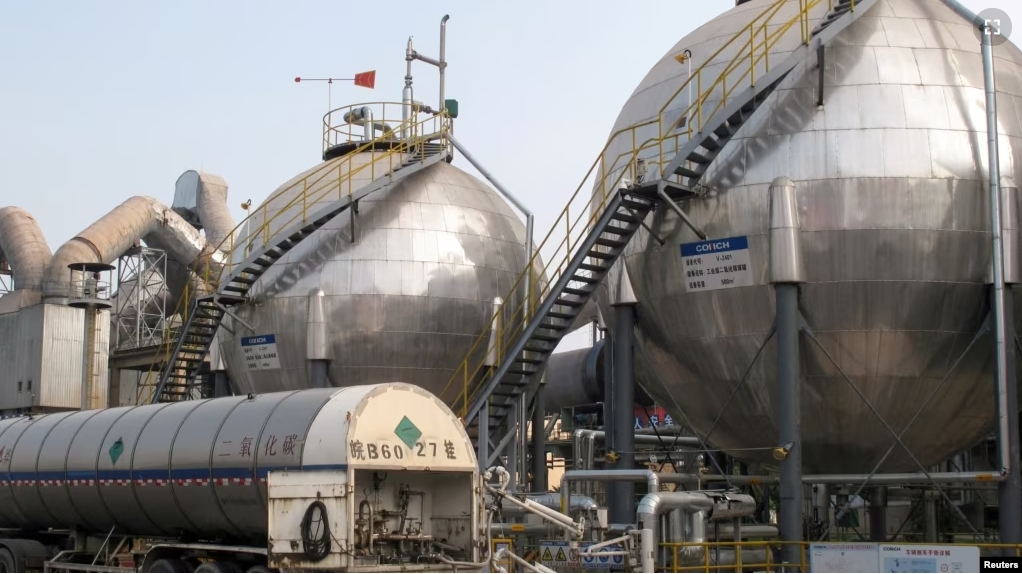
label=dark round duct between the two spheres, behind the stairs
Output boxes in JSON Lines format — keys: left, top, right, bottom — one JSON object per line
{"left": 543, "top": 339, "right": 653, "bottom": 413}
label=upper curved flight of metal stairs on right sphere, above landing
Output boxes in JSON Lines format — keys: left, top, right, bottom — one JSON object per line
{"left": 660, "top": 0, "right": 876, "bottom": 199}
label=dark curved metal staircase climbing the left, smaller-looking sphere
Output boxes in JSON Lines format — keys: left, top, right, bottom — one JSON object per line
{"left": 152, "top": 142, "right": 448, "bottom": 402}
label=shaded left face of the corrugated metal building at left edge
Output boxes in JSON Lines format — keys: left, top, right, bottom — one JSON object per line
{"left": 0, "top": 305, "right": 43, "bottom": 411}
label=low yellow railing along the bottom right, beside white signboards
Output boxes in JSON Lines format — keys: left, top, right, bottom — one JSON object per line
{"left": 656, "top": 540, "right": 1022, "bottom": 572}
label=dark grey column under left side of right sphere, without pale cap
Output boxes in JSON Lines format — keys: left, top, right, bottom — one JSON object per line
{"left": 608, "top": 301, "right": 636, "bottom": 524}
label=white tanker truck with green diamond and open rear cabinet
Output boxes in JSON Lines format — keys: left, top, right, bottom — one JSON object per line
{"left": 0, "top": 383, "right": 489, "bottom": 572}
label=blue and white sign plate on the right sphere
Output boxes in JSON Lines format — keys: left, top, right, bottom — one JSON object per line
{"left": 682, "top": 236, "right": 752, "bottom": 293}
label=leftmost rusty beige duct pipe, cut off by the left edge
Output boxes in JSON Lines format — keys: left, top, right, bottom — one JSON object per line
{"left": 0, "top": 206, "right": 52, "bottom": 291}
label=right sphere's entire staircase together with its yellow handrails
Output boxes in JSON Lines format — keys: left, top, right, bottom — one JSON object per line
{"left": 442, "top": 0, "right": 877, "bottom": 468}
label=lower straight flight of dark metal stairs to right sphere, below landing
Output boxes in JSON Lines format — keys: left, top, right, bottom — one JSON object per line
{"left": 465, "top": 190, "right": 654, "bottom": 457}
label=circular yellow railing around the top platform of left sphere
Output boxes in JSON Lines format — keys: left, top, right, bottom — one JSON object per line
{"left": 323, "top": 102, "right": 450, "bottom": 151}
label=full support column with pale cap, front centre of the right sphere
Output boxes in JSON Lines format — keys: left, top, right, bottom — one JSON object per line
{"left": 770, "top": 177, "right": 805, "bottom": 564}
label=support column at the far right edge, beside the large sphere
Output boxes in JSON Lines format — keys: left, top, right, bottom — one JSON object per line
{"left": 990, "top": 178, "right": 1022, "bottom": 544}
